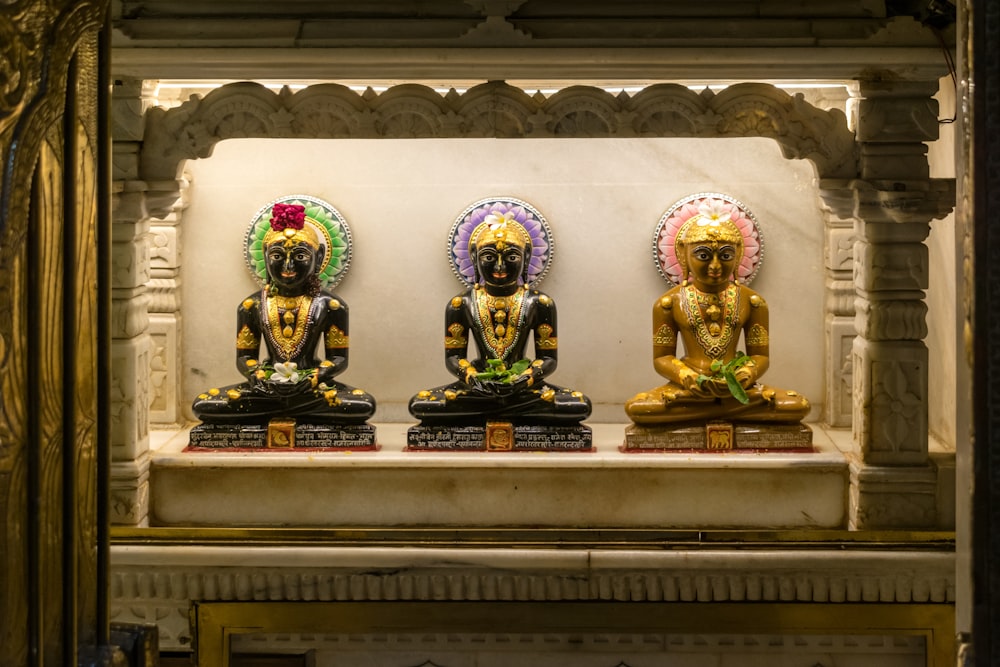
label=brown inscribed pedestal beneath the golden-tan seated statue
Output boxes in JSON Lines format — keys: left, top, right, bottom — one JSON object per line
{"left": 622, "top": 421, "right": 813, "bottom": 452}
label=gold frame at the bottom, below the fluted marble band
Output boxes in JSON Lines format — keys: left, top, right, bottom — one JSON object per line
{"left": 191, "top": 602, "right": 955, "bottom": 667}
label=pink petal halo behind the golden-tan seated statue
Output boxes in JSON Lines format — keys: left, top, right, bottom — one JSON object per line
{"left": 653, "top": 192, "right": 764, "bottom": 285}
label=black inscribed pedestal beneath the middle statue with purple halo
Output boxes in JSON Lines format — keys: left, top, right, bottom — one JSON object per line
{"left": 406, "top": 422, "right": 593, "bottom": 452}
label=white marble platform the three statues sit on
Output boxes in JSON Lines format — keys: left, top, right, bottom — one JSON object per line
{"left": 150, "top": 423, "right": 850, "bottom": 529}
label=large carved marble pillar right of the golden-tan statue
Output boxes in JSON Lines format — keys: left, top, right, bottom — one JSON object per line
{"left": 850, "top": 81, "right": 954, "bottom": 528}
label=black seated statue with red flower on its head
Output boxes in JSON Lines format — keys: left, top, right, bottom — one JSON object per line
{"left": 193, "top": 204, "right": 375, "bottom": 424}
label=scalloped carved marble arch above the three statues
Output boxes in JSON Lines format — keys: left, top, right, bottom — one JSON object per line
{"left": 140, "top": 82, "right": 858, "bottom": 217}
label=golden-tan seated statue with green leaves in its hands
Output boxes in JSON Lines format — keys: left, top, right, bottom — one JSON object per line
{"left": 625, "top": 214, "right": 809, "bottom": 426}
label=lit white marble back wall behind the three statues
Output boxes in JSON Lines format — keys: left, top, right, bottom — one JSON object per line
{"left": 180, "top": 138, "right": 825, "bottom": 423}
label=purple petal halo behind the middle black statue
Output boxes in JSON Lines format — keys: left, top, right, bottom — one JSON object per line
{"left": 448, "top": 197, "right": 555, "bottom": 287}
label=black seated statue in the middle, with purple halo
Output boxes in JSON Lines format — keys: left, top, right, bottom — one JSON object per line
{"left": 409, "top": 215, "right": 591, "bottom": 424}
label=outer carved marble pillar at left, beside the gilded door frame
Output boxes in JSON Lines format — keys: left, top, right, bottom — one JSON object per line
{"left": 111, "top": 80, "right": 152, "bottom": 525}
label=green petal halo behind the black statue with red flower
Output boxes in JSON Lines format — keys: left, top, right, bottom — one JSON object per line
{"left": 244, "top": 195, "right": 351, "bottom": 289}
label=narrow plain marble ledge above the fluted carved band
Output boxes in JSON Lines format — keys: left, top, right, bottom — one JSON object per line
{"left": 111, "top": 544, "right": 955, "bottom": 580}
